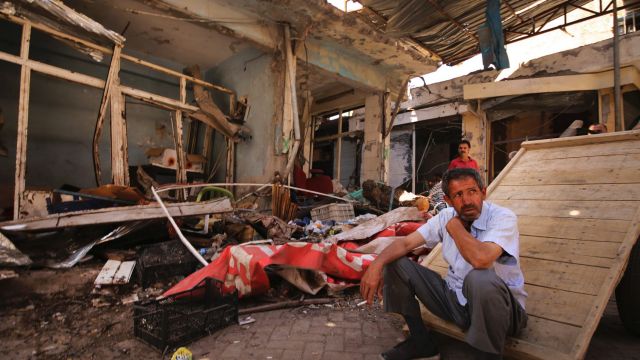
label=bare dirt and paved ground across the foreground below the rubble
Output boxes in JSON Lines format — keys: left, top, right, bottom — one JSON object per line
{"left": 0, "top": 261, "right": 640, "bottom": 360}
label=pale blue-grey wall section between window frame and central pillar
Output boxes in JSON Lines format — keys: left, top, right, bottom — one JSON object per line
{"left": 206, "top": 48, "right": 286, "bottom": 183}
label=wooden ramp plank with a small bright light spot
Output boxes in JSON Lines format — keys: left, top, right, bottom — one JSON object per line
{"left": 491, "top": 200, "right": 640, "bottom": 220}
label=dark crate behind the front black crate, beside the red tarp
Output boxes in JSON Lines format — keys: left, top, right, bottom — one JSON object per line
{"left": 136, "top": 240, "right": 199, "bottom": 287}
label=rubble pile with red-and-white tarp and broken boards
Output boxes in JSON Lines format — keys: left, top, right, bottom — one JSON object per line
{"left": 0, "top": 182, "right": 440, "bottom": 351}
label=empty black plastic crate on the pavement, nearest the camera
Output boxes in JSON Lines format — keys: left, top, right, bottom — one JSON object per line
{"left": 133, "top": 279, "right": 238, "bottom": 351}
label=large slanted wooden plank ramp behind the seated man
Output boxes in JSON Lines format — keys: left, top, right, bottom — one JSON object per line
{"left": 423, "top": 131, "right": 640, "bottom": 359}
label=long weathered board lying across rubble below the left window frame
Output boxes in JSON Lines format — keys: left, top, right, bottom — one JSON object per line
{"left": 0, "top": 198, "right": 233, "bottom": 231}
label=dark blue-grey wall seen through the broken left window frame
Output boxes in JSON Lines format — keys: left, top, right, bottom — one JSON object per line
{"left": 0, "top": 21, "right": 186, "bottom": 193}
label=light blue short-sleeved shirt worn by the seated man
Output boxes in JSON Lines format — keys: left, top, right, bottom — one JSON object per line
{"left": 418, "top": 201, "right": 527, "bottom": 309}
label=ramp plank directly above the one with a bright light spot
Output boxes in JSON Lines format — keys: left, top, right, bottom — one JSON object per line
{"left": 491, "top": 184, "right": 640, "bottom": 202}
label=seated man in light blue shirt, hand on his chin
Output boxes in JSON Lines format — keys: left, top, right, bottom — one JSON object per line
{"left": 360, "top": 168, "right": 527, "bottom": 359}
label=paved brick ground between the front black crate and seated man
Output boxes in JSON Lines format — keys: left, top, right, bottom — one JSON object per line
{"left": 182, "top": 296, "right": 640, "bottom": 360}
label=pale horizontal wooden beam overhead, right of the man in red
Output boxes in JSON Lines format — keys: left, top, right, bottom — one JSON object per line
{"left": 463, "top": 66, "right": 640, "bottom": 100}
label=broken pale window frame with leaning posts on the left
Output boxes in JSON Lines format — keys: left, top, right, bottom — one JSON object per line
{"left": 0, "top": 14, "right": 236, "bottom": 220}
